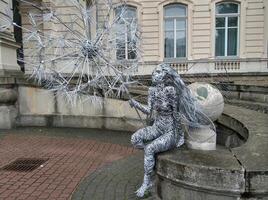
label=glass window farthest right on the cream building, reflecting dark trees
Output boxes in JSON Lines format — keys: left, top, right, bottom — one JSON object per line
{"left": 215, "top": 2, "right": 239, "bottom": 56}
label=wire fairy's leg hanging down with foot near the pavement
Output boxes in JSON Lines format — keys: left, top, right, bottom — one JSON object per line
{"left": 136, "top": 133, "right": 176, "bottom": 197}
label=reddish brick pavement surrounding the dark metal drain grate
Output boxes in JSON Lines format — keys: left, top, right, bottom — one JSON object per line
{"left": 0, "top": 129, "right": 136, "bottom": 200}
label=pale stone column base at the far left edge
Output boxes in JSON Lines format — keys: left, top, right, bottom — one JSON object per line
{"left": 0, "top": 0, "right": 19, "bottom": 129}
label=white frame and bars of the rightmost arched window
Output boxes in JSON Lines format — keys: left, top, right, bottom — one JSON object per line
{"left": 214, "top": 1, "right": 241, "bottom": 58}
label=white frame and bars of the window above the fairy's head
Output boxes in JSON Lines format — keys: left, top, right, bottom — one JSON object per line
{"left": 163, "top": 3, "right": 188, "bottom": 60}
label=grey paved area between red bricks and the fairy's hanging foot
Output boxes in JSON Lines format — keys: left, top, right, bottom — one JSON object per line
{"left": 72, "top": 152, "right": 155, "bottom": 200}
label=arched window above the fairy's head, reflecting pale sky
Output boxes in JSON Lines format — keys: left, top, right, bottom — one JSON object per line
{"left": 164, "top": 4, "right": 187, "bottom": 58}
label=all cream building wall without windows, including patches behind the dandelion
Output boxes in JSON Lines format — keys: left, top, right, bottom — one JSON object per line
{"left": 17, "top": 0, "right": 268, "bottom": 74}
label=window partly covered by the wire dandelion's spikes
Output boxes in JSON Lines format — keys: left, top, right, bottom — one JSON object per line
{"left": 115, "top": 6, "right": 137, "bottom": 60}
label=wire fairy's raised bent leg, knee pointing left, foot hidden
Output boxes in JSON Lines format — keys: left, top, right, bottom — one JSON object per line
{"left": 131, "top": 126, "right": 161, "bottom": 148}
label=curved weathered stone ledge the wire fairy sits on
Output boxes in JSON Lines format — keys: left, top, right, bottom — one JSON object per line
{"left": 156, "top": 105, "right": 268, "bottom": 200}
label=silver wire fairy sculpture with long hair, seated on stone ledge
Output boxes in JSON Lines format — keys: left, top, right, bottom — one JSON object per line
{"left": 129, "top": 64, "right": 215, "bottom": 197}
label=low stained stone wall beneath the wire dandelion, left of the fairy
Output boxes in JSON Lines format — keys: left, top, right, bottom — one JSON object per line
{"left": 17, "top": 86, "right": 144, "bottom": 131}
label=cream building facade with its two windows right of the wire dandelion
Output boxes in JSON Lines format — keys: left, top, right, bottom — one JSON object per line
{"left": 107, "top": 0, "right": 268, "bottom": 73}
